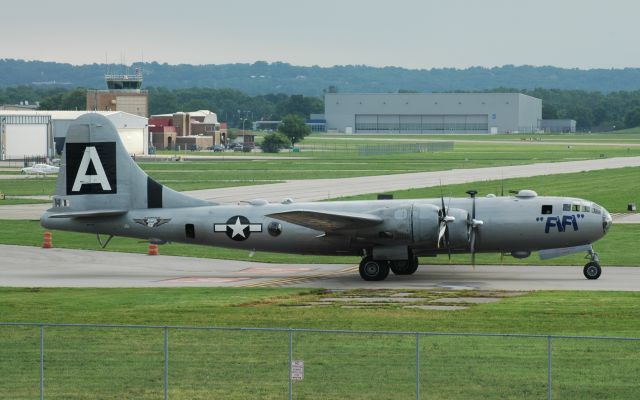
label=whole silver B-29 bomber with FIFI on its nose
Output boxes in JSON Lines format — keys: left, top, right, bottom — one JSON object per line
{"left": 41, "top": 113, "right": 612, "bottom": 281}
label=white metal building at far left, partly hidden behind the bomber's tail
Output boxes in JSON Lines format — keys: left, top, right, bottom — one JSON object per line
{"left": 0, "top": 110, "right": 149, "bottom": 160}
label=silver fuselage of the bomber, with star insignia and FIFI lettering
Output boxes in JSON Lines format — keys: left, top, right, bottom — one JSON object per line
{"left": 42, "top": 196, "right": 611, "bottom": 255}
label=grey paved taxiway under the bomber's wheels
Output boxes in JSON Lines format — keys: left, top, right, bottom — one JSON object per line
{"left": 0, "top": 245, "right": 640, "bottom": 291}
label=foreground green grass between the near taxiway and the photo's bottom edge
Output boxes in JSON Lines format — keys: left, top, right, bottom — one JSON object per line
{"left": 0, "top": 288, "right": 640, "bottom": 399}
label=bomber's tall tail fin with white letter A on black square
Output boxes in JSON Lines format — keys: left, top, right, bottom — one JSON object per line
{"left": 49, "top": 113, "right": 212, "bottom": 217}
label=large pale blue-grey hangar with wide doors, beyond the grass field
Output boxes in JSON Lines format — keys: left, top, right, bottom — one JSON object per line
{"left": 324, "top": 93, "right": 542, "bottom": 133}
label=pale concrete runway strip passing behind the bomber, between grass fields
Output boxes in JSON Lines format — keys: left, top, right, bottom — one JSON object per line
{"left": 0, "top": 157, "right": 640, "bottom": 219}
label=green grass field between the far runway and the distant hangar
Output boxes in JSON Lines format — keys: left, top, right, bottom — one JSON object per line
{"left": 0, "top": 135, "right": 640, "bottom": 196}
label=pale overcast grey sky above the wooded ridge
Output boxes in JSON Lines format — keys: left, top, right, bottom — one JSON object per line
{"left": 0, "top": 0, "right": 640, "bottom": 68}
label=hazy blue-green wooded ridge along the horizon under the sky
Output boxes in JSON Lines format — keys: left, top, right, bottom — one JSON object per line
{"left": 6, "top": 59, "right": 640, "bottom": 96}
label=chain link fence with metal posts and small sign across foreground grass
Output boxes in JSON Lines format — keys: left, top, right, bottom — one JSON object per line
{"left": 0, "top": 323, "right": 640, "bottom": 399}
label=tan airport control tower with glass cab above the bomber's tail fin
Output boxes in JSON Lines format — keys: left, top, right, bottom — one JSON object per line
{"left": 87, "top": 68, "right": 149, "bottom": 117}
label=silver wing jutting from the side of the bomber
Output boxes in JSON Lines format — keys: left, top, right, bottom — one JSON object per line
{"left": 267, "top": 210, "right": 383, "bottom": 232}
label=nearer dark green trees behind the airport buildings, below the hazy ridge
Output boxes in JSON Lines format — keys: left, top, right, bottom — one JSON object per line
{"left": 0, "top": 86, "right": 640, "bottom": 132}
